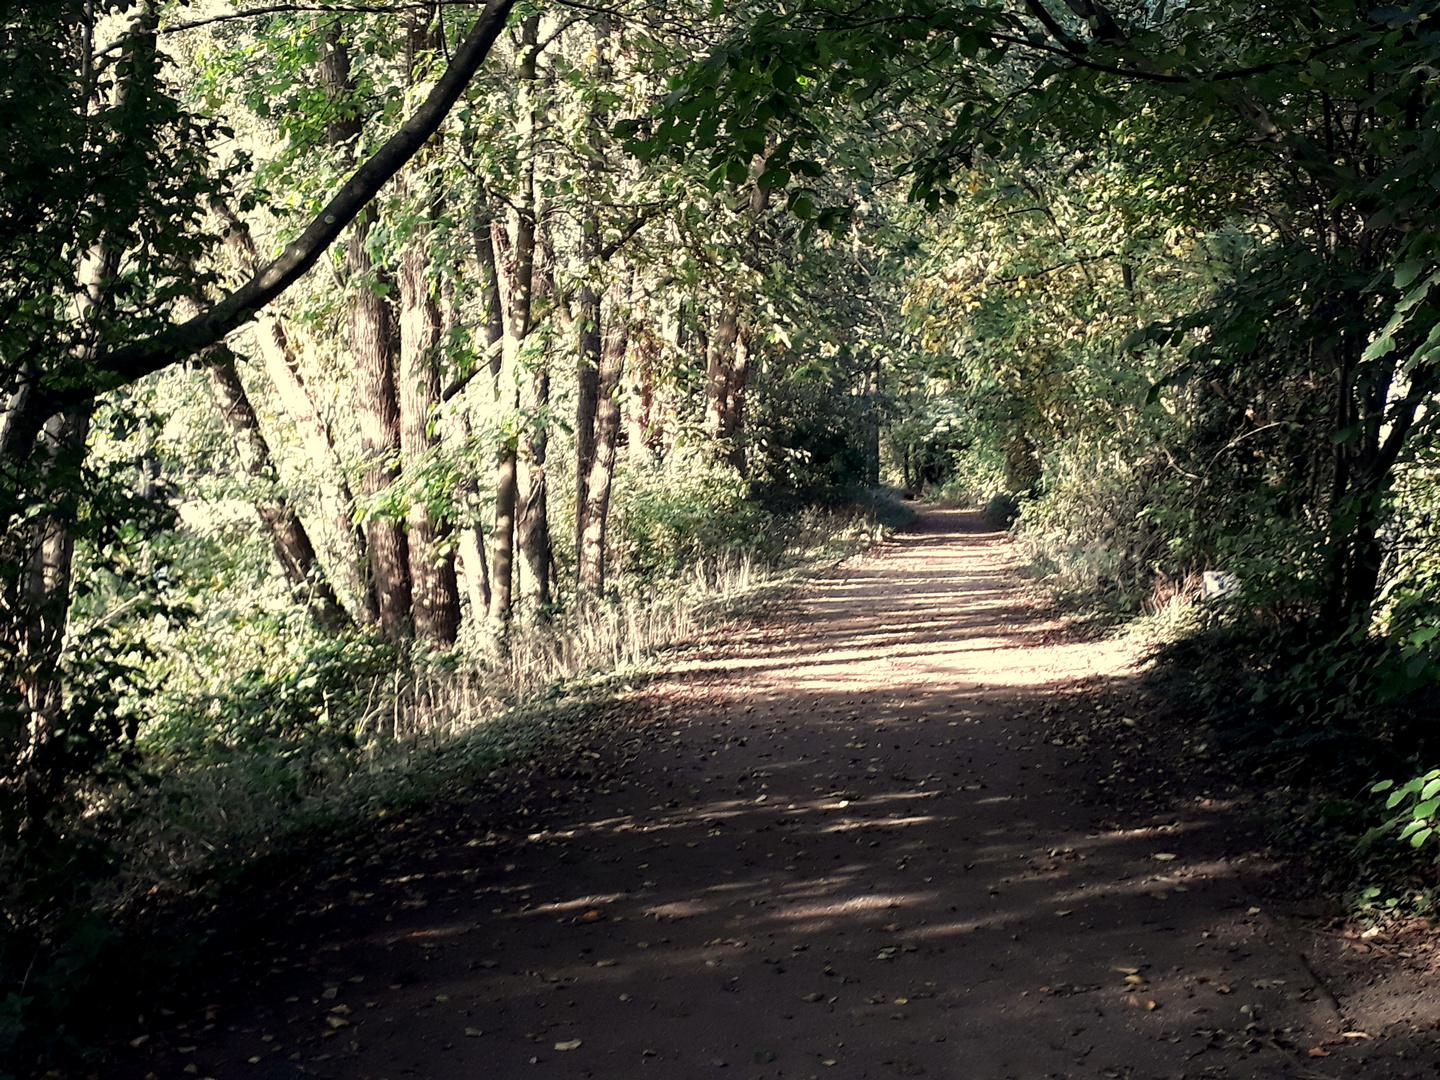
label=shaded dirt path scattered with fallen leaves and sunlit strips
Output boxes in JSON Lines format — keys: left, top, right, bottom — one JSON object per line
{"left": 102, "top": 510, "right": 1440, "bottom": 1080}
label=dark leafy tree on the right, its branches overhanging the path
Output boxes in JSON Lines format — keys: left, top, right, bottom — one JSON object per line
{"left": 632, "top": 0, "right": 1440, "bottom": 624}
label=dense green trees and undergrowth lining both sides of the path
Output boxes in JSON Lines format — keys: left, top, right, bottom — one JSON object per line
{"left": 8, "top": 0, "right": 1440, "bottom": 1077}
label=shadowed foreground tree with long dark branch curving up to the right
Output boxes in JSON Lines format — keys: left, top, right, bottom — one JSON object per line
{"left": 0, "top": 0, "right": 511, "bottom": 822}
